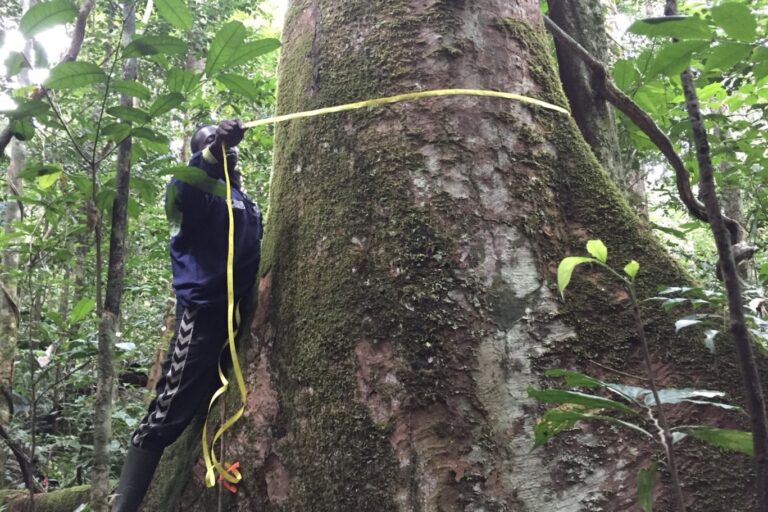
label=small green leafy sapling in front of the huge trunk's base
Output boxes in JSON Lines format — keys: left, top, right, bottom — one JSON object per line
{"left": 528, "top": 240, "right": 753, "bottom": 512}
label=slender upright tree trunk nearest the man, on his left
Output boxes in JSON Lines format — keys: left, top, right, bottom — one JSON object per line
{"left": 91, "top": 2, "right": 137, "bottom": 512}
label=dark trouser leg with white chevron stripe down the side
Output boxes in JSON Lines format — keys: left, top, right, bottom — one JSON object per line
{"left": 131, "top": 306, "right": 237, "bottom": 451}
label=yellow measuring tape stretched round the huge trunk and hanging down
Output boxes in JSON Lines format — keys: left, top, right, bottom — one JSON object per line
{"left": 198, "top": 89, "right": 570, "bottom": 487}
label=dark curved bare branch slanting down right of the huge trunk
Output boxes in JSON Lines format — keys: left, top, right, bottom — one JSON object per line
{"left": 544, "top": 16, "right": 744, "bottom": 243}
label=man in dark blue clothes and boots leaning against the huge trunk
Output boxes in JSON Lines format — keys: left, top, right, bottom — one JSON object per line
{"left": 112, "top": 119, "right": 262, "bottom": 512}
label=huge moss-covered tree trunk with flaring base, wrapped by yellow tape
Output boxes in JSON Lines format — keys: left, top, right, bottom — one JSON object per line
{"left": 145, "top": 0, "right": 751, "bottom": 512}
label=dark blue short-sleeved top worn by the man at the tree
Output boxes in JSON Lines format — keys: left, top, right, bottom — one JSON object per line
{"left": 166, "top": 152, "right": 262, "bottom": 307}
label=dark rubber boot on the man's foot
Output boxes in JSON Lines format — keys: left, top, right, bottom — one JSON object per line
{"left": 112, "top": 445, "right": 162, "bottom": 512}
